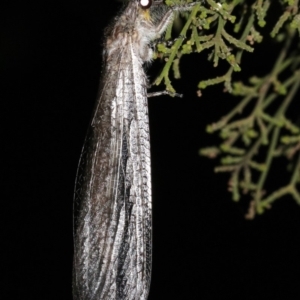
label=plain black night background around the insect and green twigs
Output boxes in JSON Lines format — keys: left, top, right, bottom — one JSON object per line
{"left": 0, "top": 0, "right": 300, "bottom": 300}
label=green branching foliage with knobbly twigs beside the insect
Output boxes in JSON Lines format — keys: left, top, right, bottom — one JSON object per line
{"left": 155, "top": 0, "right": 300, "bottom": 219}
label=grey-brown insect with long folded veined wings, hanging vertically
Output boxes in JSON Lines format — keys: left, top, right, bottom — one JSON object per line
{"left": 73, "top": 0, "right": 196, "bottom": 300}
